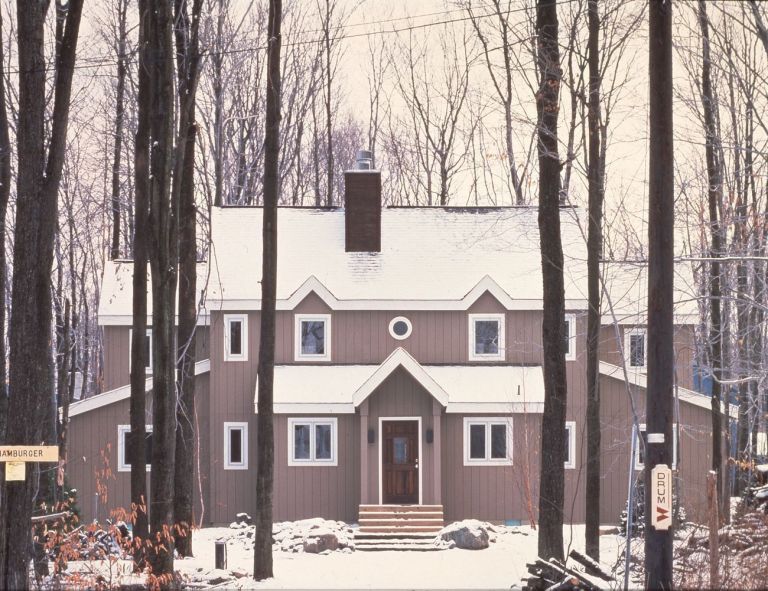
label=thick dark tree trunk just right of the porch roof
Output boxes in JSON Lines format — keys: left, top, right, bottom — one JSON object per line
{"left": 536, "top": 0, "right": 567, "bottom": 560}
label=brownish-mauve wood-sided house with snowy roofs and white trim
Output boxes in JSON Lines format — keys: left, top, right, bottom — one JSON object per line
{"left": 68, "top": 154, "right": 728, "bottom": 524}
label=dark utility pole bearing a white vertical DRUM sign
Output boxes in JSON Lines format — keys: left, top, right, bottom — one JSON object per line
{"left": 645, "top": 0, "right": 674, "bottom": 589}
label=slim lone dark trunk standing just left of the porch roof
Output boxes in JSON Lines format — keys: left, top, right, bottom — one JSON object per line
{"left": 253, "top": 0, "right": 282, "bottom": 581}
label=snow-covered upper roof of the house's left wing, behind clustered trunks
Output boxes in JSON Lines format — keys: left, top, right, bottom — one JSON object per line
{"left": 99, "top": 260, "right": 213, "bottom": 325}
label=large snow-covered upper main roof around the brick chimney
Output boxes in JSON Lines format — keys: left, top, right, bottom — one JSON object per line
{"left": 208, "top": 207, "right": 586, "bottom": 309}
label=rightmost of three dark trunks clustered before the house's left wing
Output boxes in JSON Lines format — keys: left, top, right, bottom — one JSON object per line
{"left": 173, "top": 0, "right": 202, "bottom": 556}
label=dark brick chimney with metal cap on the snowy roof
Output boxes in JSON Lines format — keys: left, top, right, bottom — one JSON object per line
{"left": 344, "top": 150, "right": 381, "bottom": 252}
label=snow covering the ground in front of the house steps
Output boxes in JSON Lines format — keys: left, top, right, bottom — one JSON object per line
{"left": 176, "top": 525, "right": 624, "bottom": 589}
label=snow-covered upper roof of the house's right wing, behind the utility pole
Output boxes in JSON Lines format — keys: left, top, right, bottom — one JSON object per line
{"left": 603, "top": 261, "right": 699, "bottom": 324}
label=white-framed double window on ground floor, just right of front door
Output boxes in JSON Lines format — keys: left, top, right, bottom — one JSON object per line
{"left": 464, "top": 417, "right": 512, "bottom": 466}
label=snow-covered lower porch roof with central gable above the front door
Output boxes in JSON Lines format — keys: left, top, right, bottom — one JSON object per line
{"left": 254, "top": 348, "right": 544, "bottom": 414}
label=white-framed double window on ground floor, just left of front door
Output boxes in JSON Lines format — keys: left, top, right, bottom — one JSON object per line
{"left": 288, "top": 418, "right": 338, "bottom": 466}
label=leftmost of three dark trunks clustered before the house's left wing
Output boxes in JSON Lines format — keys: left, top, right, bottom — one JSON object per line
{"left": 128, "top": 0, "right": 152, "bottom": 566}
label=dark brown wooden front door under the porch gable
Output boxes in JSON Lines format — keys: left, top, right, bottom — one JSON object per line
{"left": 381, "top": 421, "right": 419, "bottom": 505}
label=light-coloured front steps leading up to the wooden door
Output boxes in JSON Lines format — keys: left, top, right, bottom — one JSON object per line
{"left": 355, "top": 505, "right": 444, "bottom": 552}
